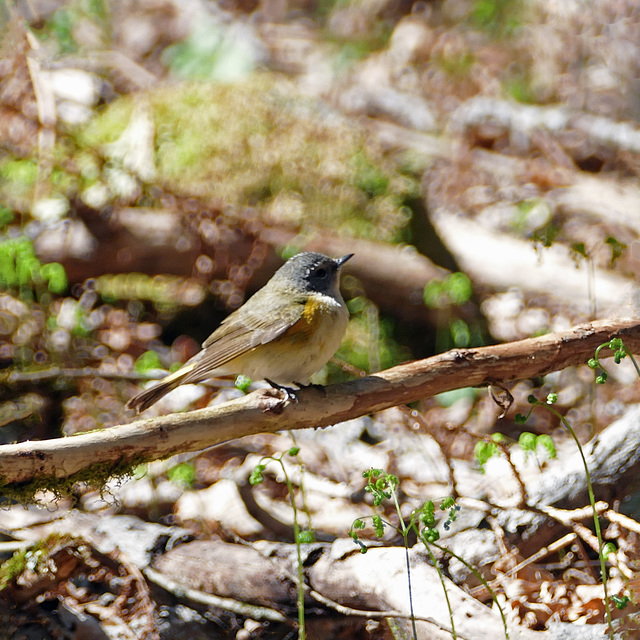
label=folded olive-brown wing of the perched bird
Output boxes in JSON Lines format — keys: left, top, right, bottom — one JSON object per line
{"left": 185, "top": 296, "right": 304, "bottom": 382}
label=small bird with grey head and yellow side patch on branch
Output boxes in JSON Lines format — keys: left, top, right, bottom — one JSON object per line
{"left": 127, "top": 252, "right": 353, "bottom": 413}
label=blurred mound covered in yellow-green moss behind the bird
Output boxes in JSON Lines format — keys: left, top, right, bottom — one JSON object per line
{"left": 79, "top": 74, "right": 418, "bottom": 242}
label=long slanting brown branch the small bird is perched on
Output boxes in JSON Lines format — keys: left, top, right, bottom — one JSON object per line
{"left": 0, "top": 319, "right": 640, "bottom": 491}
